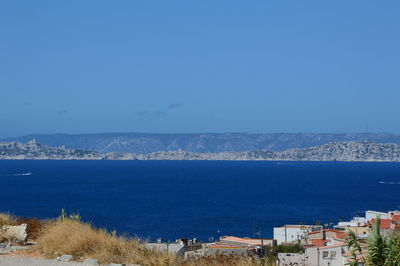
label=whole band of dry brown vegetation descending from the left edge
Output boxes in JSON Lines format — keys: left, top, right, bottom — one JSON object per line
{"left": 0, "top": 213, "right": 275, "bottom": 266}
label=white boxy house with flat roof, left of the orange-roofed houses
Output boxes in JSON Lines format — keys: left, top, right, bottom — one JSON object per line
{"left": 274, "top": 225, "right": 322, "bottom": 245}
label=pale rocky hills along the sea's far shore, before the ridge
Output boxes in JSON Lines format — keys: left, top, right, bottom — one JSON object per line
{"left": 0, "top": 141, "right": 400, "bottom": 162}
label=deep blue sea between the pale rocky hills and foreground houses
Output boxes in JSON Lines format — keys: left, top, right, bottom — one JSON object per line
{"left": 0, "top": 161, "right": 400, "bottom": 241}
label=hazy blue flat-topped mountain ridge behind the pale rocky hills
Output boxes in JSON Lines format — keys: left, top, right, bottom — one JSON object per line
{"left": 0, "top": 133, "right": 400, "bottom": 154}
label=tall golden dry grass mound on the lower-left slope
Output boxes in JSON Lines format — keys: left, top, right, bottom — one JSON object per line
{"left": 37, "top": 219, "right": 175, "bottom": 265}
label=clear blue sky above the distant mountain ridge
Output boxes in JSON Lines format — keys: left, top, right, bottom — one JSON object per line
{"left": 0, "top": 0, "right": 400, "bottom": 137}
